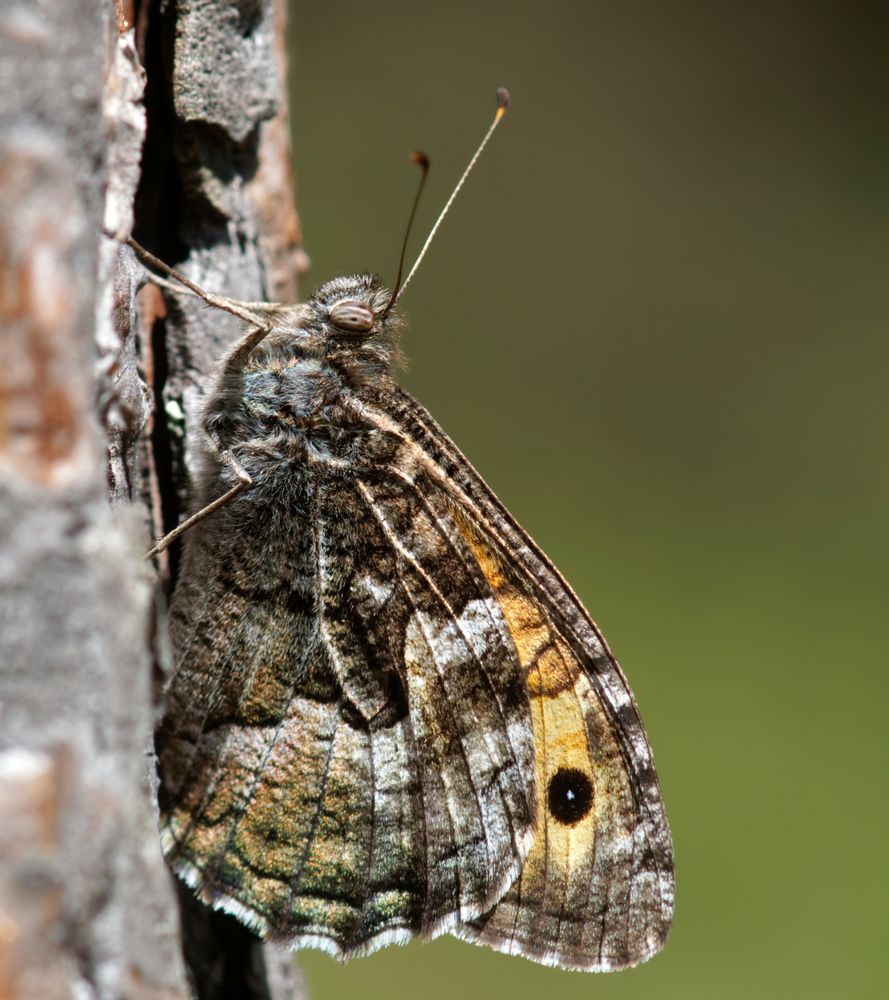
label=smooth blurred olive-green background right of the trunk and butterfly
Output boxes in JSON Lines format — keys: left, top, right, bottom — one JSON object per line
{"left": 291, "top": 0, "right": 889, "bottom": 1000}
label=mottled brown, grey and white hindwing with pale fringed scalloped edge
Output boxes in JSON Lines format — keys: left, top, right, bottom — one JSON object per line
{"left": 158, "top": 454, "right": 536, "bottom": 957}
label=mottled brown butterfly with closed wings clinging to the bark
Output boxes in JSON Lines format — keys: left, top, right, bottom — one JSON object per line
{"left": 146, "top": 92, "right": 673, "bottom": 971}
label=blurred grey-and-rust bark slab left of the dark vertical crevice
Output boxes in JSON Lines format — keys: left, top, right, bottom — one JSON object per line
{"left": 0, "top": 0, "right": 188, "bottom": 1000}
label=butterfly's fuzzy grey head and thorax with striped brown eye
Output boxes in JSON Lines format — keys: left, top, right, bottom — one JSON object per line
{"left": 201, "top": 275, "right": 399, "bottom": 503}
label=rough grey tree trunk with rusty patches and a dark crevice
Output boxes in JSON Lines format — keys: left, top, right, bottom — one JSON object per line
{"left": 0, "top": 0, "right": 303, "bottom": 1000}
